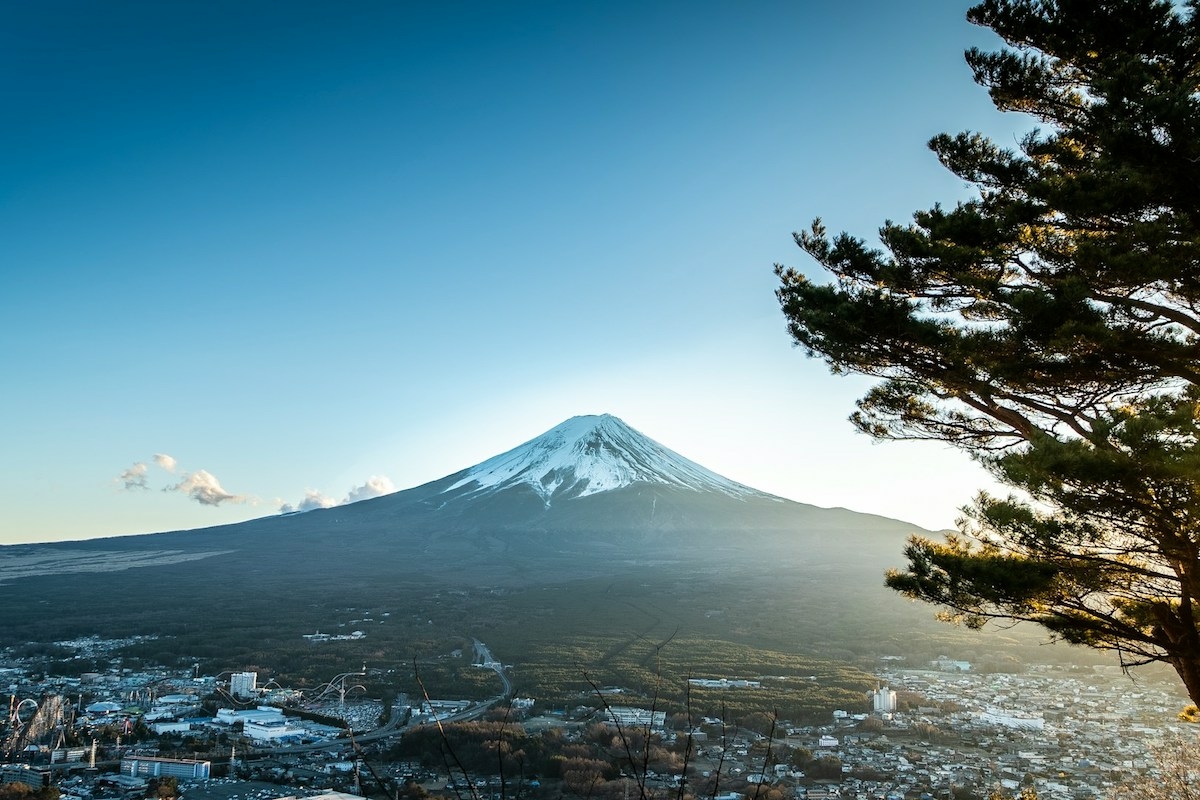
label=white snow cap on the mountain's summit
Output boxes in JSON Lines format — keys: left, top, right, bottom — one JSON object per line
{"left": 445, "top": 414, "right": 762, "bottom": 505}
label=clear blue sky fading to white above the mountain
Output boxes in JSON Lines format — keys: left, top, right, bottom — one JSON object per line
{"left": 0, "top": 0, "right": 1028, "bottom": 543}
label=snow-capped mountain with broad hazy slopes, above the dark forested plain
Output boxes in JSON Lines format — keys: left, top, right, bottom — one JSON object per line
{"left": 0, "top": 414, "right": 919, "bottom": 584}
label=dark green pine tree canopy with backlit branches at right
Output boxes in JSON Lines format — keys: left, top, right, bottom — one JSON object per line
{"left": 776, "top": 0, "right": 1200, "bottom": 703}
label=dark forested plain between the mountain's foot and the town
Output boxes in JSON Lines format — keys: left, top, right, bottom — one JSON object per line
{"left": 0, "top": 556, "right": 1099, "bottom": 721}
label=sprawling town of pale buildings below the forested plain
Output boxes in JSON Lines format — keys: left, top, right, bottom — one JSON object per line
{"left": 0, "top": 638, "right": 1189, "bottom": 800}
